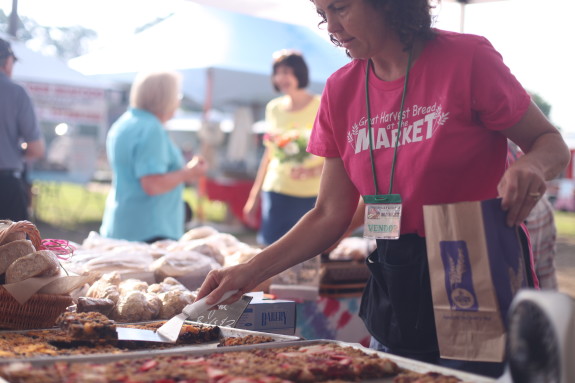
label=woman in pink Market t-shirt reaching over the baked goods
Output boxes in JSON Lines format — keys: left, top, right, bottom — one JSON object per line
{"left": 198, "top": 0, "right": 569, "bottom": 376}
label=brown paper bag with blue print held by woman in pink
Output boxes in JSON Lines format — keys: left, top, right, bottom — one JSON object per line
{"left": 423, "top": 199, "right": 528, "bottom": 362}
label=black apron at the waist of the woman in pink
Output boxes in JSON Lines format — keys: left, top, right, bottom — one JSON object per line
{"left": 359, "top": 234, "right": 439, "bottom": 353}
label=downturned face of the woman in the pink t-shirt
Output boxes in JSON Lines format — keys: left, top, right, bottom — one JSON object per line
{"left": 313, "top": 0, "right": 392, "bottom": 59}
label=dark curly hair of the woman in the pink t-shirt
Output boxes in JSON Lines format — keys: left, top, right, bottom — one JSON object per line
{"left": 311, "top": 0, "right": 434, "bottom": 50}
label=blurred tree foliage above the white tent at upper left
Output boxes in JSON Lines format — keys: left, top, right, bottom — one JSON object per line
{"left": 0, "top": 9, "right": 98, "bottom": 61}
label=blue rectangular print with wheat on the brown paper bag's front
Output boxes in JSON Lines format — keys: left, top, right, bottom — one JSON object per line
{"left": 439, "top": 241, "right": 478, "bottom": 311}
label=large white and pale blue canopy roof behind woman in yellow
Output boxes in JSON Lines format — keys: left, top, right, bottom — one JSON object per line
{"left": 69, "top": 2, "right": 349, "bottom": 108}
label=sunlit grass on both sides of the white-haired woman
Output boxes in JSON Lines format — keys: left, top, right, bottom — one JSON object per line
{"left": 33, "top": 182, "right": 227, "bottom": 230}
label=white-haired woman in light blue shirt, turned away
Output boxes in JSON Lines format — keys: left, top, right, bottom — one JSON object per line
{"left": 100, "top": 71, "right": 206, "bottom": 243}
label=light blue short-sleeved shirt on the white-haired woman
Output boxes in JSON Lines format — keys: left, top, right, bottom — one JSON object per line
{"left": 100, "top": 108, "right": 184, "bottom": 241}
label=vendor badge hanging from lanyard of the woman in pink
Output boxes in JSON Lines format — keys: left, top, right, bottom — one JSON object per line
{"left": 363, "top": 194, "right": 401, "bottom": 239}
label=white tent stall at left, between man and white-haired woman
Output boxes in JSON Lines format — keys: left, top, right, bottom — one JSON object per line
{"left": 0, "top": 34, "right": 110, "bottom": 183}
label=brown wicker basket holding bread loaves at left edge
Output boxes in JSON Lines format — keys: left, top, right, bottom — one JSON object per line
{"left": 0, "top": 286, "right": 72, "bottom": 330}
